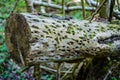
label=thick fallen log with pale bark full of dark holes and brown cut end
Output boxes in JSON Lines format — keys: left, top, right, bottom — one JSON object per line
{"left": 5, "top": 13, "right": 120, "bottom": 79}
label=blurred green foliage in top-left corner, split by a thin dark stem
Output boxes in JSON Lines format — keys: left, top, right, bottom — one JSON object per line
{"left": 0, "top": 0, "right": 26, "bottom": 19}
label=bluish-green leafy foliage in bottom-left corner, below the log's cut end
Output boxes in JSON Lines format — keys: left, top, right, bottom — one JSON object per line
{"left": 0, "top": 59, "right": 25, "bottom": 80}
